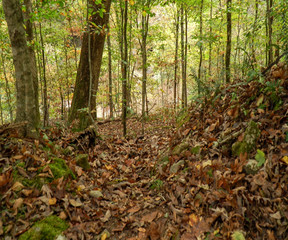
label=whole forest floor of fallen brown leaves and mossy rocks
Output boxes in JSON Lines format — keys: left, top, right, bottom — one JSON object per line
{"left": 0, "top": 62, "right": 288, "bottom": 240}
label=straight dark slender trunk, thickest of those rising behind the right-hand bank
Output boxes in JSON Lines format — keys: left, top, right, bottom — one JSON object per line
{"left": 225, "top": 0, "right": 232, "bottom": 83}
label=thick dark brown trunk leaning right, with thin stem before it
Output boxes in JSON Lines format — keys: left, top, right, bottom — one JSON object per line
{"left": 69, "top": 0, "right": 111, "bottom": 129}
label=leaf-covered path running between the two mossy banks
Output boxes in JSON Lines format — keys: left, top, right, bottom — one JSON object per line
{"left": 66, "top": 119, "right": 178, "bottom": 240}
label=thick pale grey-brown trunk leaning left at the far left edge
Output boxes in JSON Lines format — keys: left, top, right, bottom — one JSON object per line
{"left": 2, "top": 0, "right": 39, "bottom": 137}
